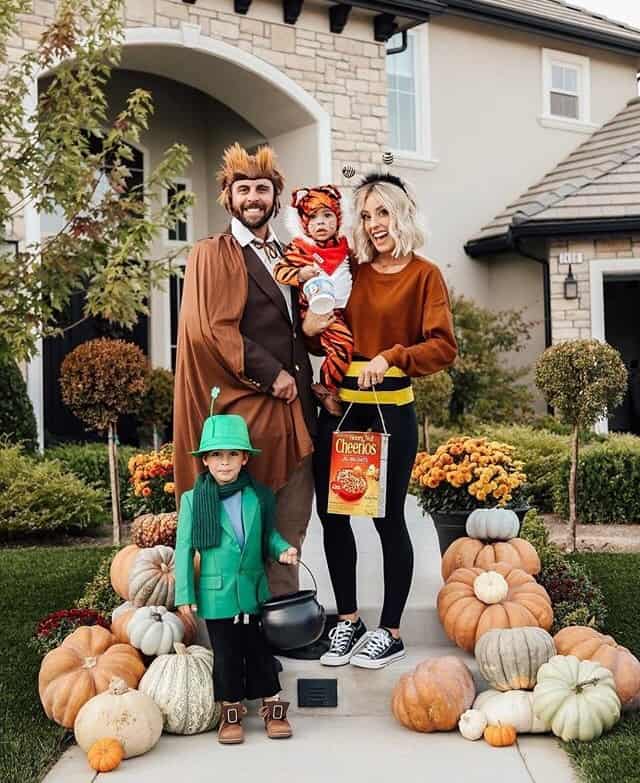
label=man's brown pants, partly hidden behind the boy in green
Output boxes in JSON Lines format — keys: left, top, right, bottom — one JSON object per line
{"left": 267, "top": 456, "right": 313, "bottom": 596}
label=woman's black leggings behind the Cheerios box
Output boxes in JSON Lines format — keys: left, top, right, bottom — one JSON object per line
{"left": 313, "top": 403, "right": 418, "bottom": 628}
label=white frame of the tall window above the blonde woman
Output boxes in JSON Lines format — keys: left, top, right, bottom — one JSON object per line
{"left": 385, "top": 23, "right": 437, "bottom": 169}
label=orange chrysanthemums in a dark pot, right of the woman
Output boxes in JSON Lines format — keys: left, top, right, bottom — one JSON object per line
{"left": 411, "top": 436, "right": 528, "bottom": 553}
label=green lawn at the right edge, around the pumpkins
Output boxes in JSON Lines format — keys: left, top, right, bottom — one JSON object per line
{"left": 564, "top": 553, "right": 640, "bottom": 783}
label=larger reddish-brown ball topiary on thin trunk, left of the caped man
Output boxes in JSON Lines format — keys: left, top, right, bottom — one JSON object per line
{"left": 60, "top": 337, "right": 148, "bottom": 546}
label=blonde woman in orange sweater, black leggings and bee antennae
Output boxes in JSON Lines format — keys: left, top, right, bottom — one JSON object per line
{"left": 305, "top": 174, "right": 457, "bottom": 669}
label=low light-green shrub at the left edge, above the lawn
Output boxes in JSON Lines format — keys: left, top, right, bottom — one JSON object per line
{"left": 0, "top": 445, "right": 104, "bottom": 539}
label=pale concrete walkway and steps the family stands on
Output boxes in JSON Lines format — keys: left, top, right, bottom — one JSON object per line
{"left": 44, "top": 498, "right": 577, "bottom": 783}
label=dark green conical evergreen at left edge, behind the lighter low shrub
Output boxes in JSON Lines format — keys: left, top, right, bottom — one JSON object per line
{"left": 0, "top": 354, "right": 38, "bottom": 451}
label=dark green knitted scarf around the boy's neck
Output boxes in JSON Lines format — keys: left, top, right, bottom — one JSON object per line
{"left": 192, "top": 468, "right": 276, "bottom": 560}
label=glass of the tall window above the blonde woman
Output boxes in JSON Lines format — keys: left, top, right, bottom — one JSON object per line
{"left": 387, "top": 32, "right": 424, "bottom": 154}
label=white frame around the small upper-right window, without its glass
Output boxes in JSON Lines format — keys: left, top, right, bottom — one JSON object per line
{"left": 538, "top": 49, "right": 598, "bottom": 133}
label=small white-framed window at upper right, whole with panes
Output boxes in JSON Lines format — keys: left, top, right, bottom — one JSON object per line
{"left": 541, "top": 49, "right": 591, "bottom": 127}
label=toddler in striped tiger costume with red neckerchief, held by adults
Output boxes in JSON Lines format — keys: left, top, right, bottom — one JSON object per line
{"left": 274, "top": 185, "right": 353, "bottom": 416}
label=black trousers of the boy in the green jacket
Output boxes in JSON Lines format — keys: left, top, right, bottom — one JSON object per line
{"left": 207, "top": 615, "right": 281, "bottom": 701}
